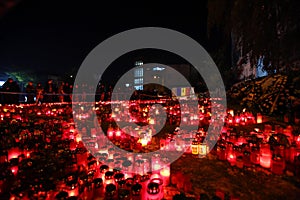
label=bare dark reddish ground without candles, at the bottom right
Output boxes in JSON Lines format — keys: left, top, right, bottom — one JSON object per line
{"left": 171, "top": 155, "right": 300, "bottom": 200}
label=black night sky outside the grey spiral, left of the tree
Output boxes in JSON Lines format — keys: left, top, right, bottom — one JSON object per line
{"left": 0, "top": 0, "right": 207, "bottom": 77}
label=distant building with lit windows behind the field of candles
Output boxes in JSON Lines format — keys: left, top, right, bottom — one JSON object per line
{"left": 116, "top": 61, "right": 194, "bottom": 97}
